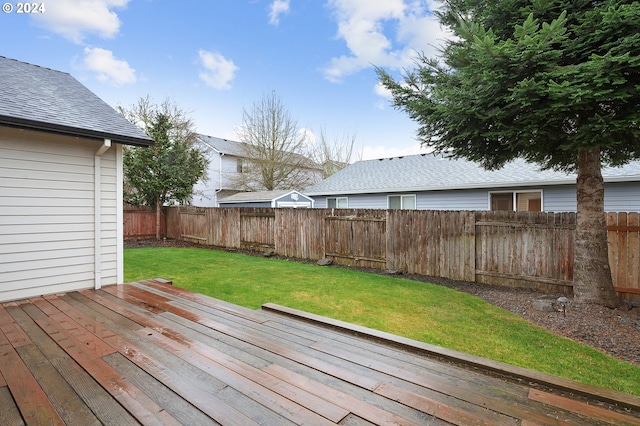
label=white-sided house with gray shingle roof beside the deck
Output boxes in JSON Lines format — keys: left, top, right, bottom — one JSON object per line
{"left": 0, "top": 57, "right": 153, "bottom": 301}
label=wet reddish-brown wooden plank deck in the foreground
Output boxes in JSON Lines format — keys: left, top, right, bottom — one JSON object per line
{"left": 0, "top": 280, "right": 640, "bottom": 426}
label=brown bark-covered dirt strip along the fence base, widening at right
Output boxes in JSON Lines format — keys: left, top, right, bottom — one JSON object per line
{"left": 125, "top": 240, "right": 640, "bottom": 366}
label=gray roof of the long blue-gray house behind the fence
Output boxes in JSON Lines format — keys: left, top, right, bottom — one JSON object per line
{"left": 305, "top": 154, "right": 640, "bottom": 196}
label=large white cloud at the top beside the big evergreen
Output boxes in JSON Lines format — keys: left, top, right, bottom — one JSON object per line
{"left": 323, "top": 0, "right": 447, "bottom": 82}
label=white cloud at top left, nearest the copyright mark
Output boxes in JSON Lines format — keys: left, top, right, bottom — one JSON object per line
{"left": 31, "top": 0, "right": 130, "bottom": 44}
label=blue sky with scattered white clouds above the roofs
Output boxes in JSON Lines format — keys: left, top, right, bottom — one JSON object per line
{"left": 0, "top": 0, "right": 446, "bottom": 159}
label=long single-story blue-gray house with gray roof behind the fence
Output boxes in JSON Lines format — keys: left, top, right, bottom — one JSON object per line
{"left": 304, "top": 154, "right": 640, "bottom": 212}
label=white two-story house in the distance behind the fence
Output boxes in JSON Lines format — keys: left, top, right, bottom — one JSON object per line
{"left": 191, "top": 134, "right": 322, "bottom": 207}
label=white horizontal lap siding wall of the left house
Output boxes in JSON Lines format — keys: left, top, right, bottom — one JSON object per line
{"left": 0, "top": 128, "right": 121, "bottom": 300}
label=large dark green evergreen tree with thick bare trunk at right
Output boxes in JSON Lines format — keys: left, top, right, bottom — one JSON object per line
{"left": 378, "top": 0, "right": 640, "bottom": 307}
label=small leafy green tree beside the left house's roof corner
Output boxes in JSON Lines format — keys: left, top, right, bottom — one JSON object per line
{"left": 121, "top": 98, "right": 207, "bottom": 239}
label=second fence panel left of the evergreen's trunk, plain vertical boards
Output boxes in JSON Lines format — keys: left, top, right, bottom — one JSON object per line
{"left": 387, "top": 210, "right": 475, "bottom": 281}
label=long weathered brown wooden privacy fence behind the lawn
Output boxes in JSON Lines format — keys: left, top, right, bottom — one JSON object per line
{"left": 125, "top": 207, "right": 640, "bottom": 301}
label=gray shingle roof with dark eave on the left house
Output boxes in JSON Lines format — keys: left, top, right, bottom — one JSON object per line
{"left": 0, "top": 56, "right": 153, "bottom": 146}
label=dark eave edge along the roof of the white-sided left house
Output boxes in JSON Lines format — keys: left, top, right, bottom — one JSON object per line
{"left": 0, "top": 115, "right": 155, "bottom": 146}
